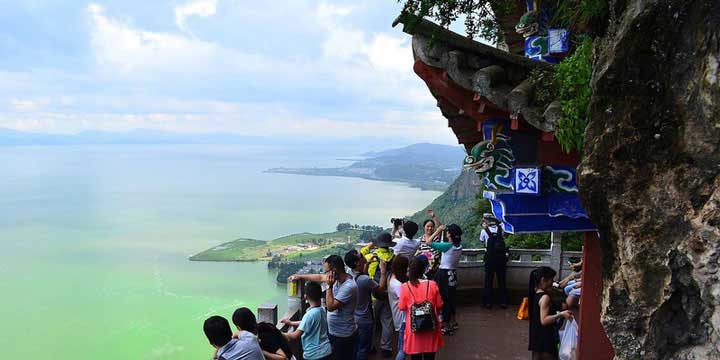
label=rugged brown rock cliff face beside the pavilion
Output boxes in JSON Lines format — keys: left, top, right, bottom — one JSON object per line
{"left": 579, "top": 0, "right": 720, "bottom": 359}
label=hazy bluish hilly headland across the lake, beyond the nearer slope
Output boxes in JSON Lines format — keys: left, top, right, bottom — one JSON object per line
{"left": 267, "top": 143, "right": 465, "bottom": 191}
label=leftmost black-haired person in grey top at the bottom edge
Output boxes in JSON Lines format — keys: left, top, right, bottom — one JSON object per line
{"left": 203, "top": 315, "right": 265, "bottom": 360}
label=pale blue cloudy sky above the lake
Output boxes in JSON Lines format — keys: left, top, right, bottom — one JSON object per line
{"left": 0, "top": 0, "right": 457, "bottom": 144}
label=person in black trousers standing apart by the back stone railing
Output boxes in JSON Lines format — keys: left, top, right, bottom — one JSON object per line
{"left": 480, "top": 214, "right": 509, "bottom": 309}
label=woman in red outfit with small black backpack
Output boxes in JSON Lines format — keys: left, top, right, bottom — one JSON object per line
{"left": 398, "top": 258, "right": 443, "bottom": 360}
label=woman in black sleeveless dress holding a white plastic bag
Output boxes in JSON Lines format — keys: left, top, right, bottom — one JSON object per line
{"left": 528, "top": 266, "right": 572, "bottom": 360}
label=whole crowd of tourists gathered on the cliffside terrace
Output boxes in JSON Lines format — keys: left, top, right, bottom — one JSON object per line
{"left": 204, "top": 210, "right": 580, "bottom": 360}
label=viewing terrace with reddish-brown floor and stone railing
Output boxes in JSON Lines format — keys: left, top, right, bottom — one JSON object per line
{"left": 257, "top": 233, "right": 582, "bottom": 360}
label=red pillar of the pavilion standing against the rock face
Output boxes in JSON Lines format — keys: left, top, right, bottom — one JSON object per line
{"left": 577, "top": 232, "right": 615, "bottom": 360}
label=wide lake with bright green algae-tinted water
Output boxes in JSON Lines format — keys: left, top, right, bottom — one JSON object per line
{"left": 0, "top": 145, "right": 439, "bottom": 359}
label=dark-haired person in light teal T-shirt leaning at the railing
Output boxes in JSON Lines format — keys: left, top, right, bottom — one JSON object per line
{"left": 282, "top": 281, "right": 332, "bottom": 360}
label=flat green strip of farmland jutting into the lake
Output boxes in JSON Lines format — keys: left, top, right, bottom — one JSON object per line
{"left": 190, "top": 229, "right": 363, "bottom": 261}
